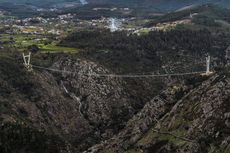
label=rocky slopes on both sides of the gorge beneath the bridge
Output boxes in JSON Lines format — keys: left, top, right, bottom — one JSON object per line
{"left": 0, "top": 58, "right": 230, "bottom": 153}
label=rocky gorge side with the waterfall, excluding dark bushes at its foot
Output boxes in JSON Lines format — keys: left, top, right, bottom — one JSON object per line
{"left": 0, "top": 59, "right": 138, "bottom": 150}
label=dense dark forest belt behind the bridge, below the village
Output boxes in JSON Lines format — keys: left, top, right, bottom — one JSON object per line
{"left": 60, "top": 30, "right": 229, "bottom": 72}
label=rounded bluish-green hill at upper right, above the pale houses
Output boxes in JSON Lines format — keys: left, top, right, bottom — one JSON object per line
{"left": 146, "top": 4, "right": 230, "bottom": 30}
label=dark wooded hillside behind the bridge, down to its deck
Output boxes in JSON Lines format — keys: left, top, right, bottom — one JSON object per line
{"left": 60, "top": 28, "right": 229, "bottom": 74}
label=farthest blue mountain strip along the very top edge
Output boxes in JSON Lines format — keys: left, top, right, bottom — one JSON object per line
{"left": 0, "top": 0, "right": 230, "bottom": 11}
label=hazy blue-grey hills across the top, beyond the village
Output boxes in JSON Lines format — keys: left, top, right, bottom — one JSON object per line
{"left": 0, "top": 0, "right": 229, "bottom": 18}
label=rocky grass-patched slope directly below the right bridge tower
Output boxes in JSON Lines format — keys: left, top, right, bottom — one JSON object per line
{"left": 133, "top": 74, "right": 230, "bottom": 153}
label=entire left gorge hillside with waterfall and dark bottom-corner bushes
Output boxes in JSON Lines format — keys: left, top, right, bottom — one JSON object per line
{"left": 0, "top": 55, "right": 163, "bottom": 153}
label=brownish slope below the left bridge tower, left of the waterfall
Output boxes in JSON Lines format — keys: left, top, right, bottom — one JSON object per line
{"left": 0, "top": 57, "right": 93, "bottom": 151}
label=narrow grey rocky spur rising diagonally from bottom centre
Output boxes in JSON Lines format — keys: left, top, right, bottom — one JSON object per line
{"left": 83, "top": 97, "right": 170, "bottom": 153}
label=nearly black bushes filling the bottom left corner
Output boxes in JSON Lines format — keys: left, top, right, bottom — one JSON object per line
{"left": 0, "top": 123, "right": 70, "bottom": 153}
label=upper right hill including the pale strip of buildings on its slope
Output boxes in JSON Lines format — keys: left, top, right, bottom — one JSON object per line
{"left": 146, "top": 4, "right": 230, "bottom": 31}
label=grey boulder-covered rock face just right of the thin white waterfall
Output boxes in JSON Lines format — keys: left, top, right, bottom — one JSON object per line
{"left": 54, "top": 60, "right": 134, "bottom": 135}
